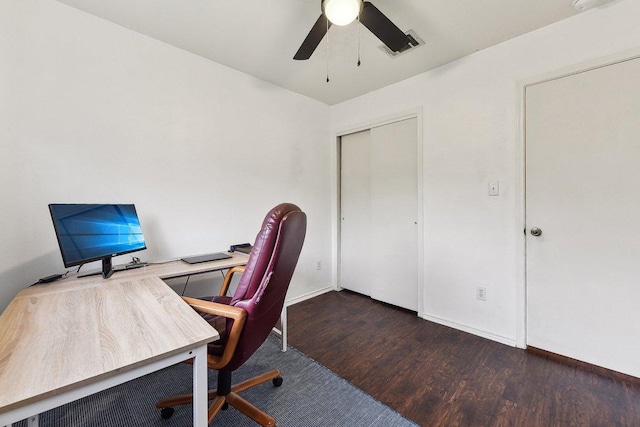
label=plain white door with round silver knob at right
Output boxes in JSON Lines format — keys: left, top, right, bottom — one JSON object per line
{"left": 526, "top": 59, "right": 640, "bottom": 377}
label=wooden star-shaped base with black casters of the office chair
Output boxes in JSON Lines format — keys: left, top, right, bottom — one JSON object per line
{"left": 156, "top": 369, "right": 282, "bottom": 426}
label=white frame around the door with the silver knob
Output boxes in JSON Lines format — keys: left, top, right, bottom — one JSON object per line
{"left": 515, "top": 48, "right": 640, "bottom": 348}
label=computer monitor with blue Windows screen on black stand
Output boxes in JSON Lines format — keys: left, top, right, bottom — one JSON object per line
{"left": 49, "top": 204, "right": 147, "bottom": 279}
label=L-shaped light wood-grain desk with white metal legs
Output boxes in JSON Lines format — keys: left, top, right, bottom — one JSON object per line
{"left": 0, "top": 254, "right": 247, "bottom": 426}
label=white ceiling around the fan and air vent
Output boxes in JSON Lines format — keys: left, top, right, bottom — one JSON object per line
{"left": 58, "top": 0, "right": 578, "bottom": 105}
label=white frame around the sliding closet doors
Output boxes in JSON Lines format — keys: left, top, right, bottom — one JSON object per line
{"left": 332, "top": 107, "right": 424, "bottom": 317}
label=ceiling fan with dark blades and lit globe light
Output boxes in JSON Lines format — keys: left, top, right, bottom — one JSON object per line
{"left": 293, "top": 0, "right": 412, "bottom": 60}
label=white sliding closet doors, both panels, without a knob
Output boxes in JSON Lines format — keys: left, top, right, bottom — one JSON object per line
{"left": 341, "top": 119, "right": 418, "bottom": 311}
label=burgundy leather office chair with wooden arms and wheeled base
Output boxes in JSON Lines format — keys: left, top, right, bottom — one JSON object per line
{"left": 156, "top": 203, "right": 307, "bottom": 426}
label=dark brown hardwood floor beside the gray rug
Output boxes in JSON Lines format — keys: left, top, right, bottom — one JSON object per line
{"left": 288, "top": 291, "right": 640, "bottom": 426}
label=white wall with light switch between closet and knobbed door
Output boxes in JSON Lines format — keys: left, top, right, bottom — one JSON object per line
{"left": 331, "top": 0, "right": 640, "bottom": 344}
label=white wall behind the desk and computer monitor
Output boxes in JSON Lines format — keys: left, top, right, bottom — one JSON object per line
{"left": 0, "top": 0, "right": 331, "bottom": 311}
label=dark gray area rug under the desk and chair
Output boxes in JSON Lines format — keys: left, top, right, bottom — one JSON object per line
{"left": 17, "top": 337, "right": 416, "bottom": 427}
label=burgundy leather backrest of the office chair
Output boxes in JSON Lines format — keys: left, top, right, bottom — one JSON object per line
{"left": 224, "top": 203, "right": 307, "bottom": 371}
